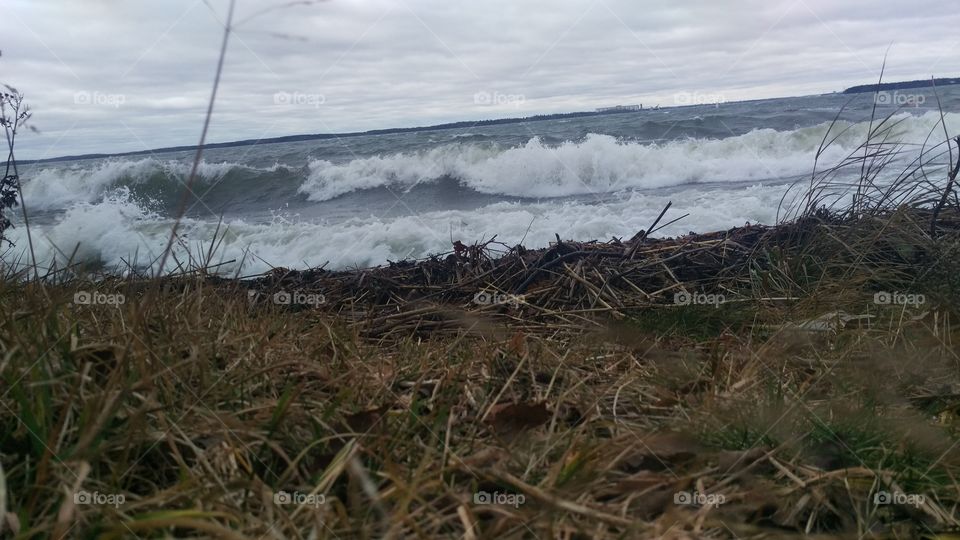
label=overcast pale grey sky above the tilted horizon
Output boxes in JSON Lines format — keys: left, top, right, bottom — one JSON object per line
{"left": 0, "top": 0, "right": 960, "bottom": 159}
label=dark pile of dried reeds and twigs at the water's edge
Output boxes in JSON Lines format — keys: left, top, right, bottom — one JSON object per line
{"left": 240, "top": 216, "right": 800, "bottom": 334}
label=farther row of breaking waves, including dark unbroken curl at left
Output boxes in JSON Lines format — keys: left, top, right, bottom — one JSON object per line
{"left": 23, "top": 112, "right": 960, "bottom": 218}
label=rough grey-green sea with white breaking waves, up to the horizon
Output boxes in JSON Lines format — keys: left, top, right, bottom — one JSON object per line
{"left": 2, "top": 87, "right": 960, "bottom": 276}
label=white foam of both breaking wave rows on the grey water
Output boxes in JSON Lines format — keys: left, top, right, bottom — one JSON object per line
{"left": 3, "top": 109, "right": 960, "bottom": 274}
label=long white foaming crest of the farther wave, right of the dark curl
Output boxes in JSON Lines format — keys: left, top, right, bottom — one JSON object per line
{"left": 299, "top": 112, "right": 960, "bottom": 201}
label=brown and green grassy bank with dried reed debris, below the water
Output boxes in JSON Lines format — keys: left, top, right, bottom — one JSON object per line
{"left": 0, "top": 205, "right": 960, "bottom": 538}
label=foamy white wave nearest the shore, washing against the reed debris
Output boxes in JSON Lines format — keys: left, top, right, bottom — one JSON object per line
{"left": 3, "top": 185, "right": 800, "bottom": 275}
